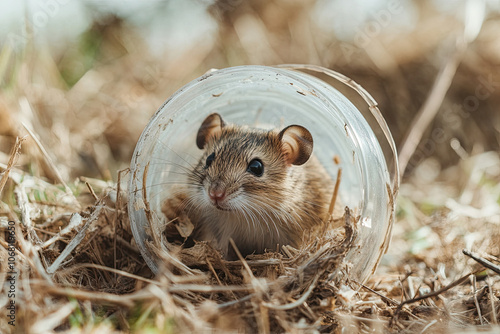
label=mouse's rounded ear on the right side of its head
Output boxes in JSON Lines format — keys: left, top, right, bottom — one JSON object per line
{"left": 278, "top": 125, "right": 313, "bottom": 165}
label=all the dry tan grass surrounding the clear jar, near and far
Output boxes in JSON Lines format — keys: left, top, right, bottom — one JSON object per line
{"left": 0, "top": 0, "right": 500, "bottom": 333}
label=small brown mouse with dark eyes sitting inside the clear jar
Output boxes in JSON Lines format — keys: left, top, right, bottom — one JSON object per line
{"left": 163, "top": 113, "right": 333, "bottom": 260}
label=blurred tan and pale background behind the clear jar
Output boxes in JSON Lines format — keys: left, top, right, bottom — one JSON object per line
{"left": 0, "top": 0, "right": 500, "bottom": 261}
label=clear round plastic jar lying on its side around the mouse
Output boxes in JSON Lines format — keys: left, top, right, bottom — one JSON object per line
{"left": 129, "top": 65, "right": 399, "bottom": 281}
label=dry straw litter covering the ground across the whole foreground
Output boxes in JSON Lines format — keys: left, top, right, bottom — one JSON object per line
{"left": 0, "top": 137, "right": 500, "bottom": 333}
